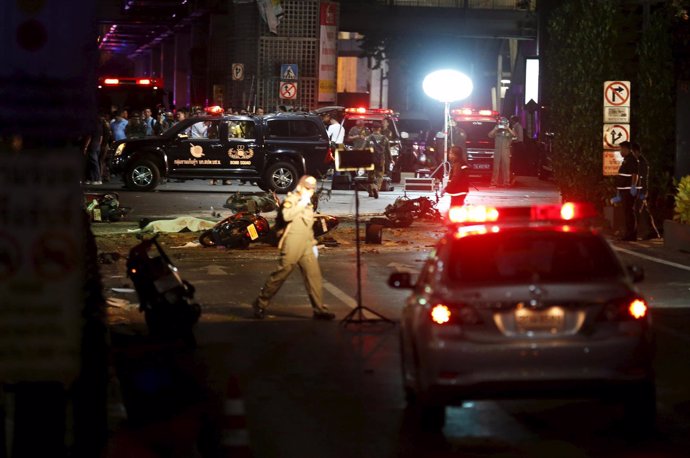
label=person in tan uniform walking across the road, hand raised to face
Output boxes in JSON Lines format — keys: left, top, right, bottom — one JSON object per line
{"left": 253, "top": 175, "right": 335, "bottom": 320}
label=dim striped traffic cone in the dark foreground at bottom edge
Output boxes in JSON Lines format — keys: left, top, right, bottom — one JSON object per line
{"left": 221, "top": 376, "right": 252, "bottom": 458}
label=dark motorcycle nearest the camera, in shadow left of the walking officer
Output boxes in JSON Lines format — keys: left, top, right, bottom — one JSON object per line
{"left": 127, "top": 236, "right": 201, "bottom": 347}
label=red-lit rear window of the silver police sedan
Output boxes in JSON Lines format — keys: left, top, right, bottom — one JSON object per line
{"left": 448, "top": 231, "right": 623, "bottom": 283}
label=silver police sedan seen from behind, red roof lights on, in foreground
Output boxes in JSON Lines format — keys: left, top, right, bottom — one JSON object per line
{"left": 389, "top": 203, "right": 656, "bottom": 430}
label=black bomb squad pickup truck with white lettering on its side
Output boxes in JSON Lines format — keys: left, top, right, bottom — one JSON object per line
{"left": 111, "top": 113, "right": 333, "bottom": 193}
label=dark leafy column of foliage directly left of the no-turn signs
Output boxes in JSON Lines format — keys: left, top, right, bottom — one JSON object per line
{"left": 543, "top": 0, "right": 626, "bottom": 202}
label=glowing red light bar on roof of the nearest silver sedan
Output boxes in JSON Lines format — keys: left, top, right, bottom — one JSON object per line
{"left": 448, "top": 202, "right": 597, "bottom": 225}
